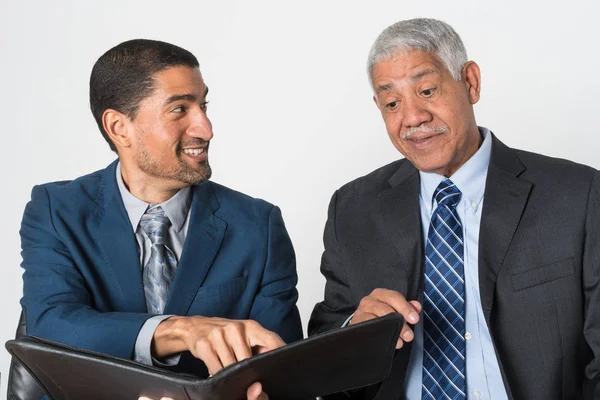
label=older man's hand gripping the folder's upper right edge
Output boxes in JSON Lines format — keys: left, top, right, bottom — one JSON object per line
{"left": 349, "top": 289, "right": 423, "bottom": 349}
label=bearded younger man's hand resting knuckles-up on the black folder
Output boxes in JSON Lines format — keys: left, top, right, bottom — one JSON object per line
{"left": 152, "top": 316, "right": 285, "bottom": 375}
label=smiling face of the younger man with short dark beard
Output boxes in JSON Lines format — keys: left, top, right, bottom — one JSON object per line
{"left": 124, "top": 66, "right": 213, "bottom": 189}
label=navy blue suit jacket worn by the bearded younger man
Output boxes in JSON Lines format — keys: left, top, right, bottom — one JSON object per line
{"left": 21, "top": 161, "right": 302, "bottom": 373}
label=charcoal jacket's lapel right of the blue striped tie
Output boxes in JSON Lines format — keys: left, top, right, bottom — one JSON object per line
{"left": 479, "top": 136, "right": 532, "bottom": 324}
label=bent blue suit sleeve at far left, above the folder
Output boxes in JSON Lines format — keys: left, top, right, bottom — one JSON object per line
{"left": 20, "top": 186, "right": 150, "bottom": 358}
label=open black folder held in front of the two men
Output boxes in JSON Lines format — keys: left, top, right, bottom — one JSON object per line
{"left": 6, "top": 314, "right": 404, "bottom": 400}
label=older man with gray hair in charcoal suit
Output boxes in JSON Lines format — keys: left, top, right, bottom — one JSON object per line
{"left": 308, "top": 19, "right": 600, "bottom": 400}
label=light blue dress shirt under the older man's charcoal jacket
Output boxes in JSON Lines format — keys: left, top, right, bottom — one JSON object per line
{"left": 405, "top": 127, "right": 507, "bottom": 400}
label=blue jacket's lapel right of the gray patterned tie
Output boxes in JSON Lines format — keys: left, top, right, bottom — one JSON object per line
{"left": 165, "top": 182, "right": 227, "bottom": 315}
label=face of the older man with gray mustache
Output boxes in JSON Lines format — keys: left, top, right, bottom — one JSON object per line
{"left": 371, "top": 50, "right": 481, "bottom": 176}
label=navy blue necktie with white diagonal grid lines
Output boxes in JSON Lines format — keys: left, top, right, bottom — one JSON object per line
{"left": 422, "top": 179, "right": 466, "bottom": 400}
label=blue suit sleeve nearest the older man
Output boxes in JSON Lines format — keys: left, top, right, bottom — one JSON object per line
{"left": 250, "top": 206, "right": 302, "bottom": 343}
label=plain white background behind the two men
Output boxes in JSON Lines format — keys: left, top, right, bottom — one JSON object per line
{"left": 0, "top": 0, "right": 600, "bottom": 398}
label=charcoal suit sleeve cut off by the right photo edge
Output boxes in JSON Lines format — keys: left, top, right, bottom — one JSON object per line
{"left": 583, "top": 171, "right": 600, "bottom": 400}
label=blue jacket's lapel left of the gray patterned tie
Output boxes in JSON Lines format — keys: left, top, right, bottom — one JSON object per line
{"left": 96, "top": 161, "right": 146, "bottom": 312}
